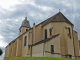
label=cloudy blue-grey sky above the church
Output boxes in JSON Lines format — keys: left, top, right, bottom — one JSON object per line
{"left": 0, "top": 0, "right": 80, "bottom": 60}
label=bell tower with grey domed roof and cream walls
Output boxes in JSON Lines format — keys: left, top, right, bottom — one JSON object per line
{"left": 18, "top": 17, "right": 31, "bottom": 36}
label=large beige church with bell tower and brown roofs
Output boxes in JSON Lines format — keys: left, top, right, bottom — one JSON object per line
{"left": 5, "top": 11, "right": 80, "bottom": 59}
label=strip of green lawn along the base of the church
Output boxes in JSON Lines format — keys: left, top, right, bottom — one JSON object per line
{"left": 4, "top": 57, "right": 80, "bottom": 60}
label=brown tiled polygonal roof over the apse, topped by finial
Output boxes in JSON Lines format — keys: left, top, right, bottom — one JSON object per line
{"left": 42, "top": 12, "right": 73, "bottom": 26}
